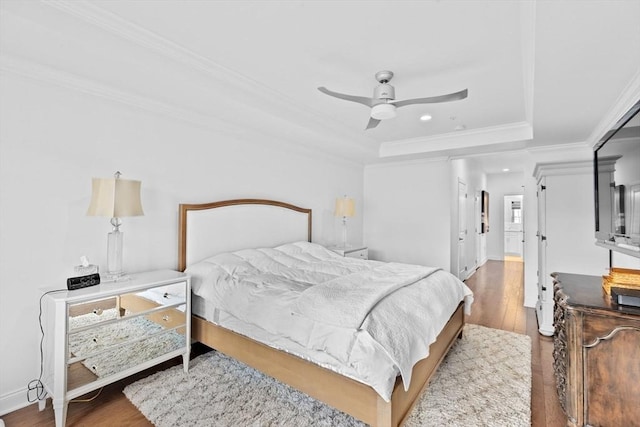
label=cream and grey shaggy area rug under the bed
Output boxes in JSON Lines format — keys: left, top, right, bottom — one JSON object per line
{"left": 124, "top": 325, "right": 531, "bottom": 427}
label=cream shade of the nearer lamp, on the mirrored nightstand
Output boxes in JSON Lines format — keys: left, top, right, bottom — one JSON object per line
{"left": 87, "top": 178, "right": 144, "bottom": 218}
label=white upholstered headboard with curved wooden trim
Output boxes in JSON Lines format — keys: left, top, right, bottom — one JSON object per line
{"left": 178, "top": 199, "right": 311, "bottom": 271}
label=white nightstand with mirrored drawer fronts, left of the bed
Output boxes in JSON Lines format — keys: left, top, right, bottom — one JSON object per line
{"left": 39, "top": 270, "right": 191, "bottom": 427}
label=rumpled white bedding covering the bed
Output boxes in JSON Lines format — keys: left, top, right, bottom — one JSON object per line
{"left": 186, "top": 242, "right": 473, "bottom": 401}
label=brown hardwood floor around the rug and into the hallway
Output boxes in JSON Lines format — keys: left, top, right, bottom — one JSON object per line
{"left": 2, "top": 261, "right": 566, "bottom": 427}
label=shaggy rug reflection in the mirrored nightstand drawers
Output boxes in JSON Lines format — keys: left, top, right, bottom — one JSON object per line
{"left": 69, "top": 308, "right": 184, "bottom": 377}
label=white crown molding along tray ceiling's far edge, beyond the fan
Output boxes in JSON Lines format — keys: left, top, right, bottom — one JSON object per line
{"left": 379, "top": 122, "right": 533, "bottom": 157}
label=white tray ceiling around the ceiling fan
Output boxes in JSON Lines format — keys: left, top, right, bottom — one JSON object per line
{"left": 0, "top": 0, "right": 640, "bottom": 169}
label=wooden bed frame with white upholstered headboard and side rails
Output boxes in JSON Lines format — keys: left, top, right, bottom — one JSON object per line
{"left": 178, "top": 199, "right": 464, "bottom": 427}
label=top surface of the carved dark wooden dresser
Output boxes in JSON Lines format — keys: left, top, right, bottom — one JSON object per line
{"left": 552, "top": 273, "right": 640, "bottom": 315}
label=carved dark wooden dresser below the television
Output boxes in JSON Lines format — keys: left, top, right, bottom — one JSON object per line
{"left": 552, "top": 273, "right": 640, "bottom": 427}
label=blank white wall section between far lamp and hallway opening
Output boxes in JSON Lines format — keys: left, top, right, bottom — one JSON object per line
{"left": 364, "top": 160, "right": 455, "bottom": 270}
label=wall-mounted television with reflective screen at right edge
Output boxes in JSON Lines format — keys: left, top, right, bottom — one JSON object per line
{"left": 594, "top": 101, "right": 640, "bottom": 258}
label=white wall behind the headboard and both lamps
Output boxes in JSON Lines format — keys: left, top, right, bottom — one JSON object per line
{"left": 0, "top": 73, "right": 364, "bottom": 414}
